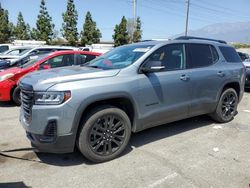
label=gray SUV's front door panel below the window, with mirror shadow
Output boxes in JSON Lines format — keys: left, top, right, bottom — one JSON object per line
{"left": 136, "top": 43, "right": 191, "bottom": 129}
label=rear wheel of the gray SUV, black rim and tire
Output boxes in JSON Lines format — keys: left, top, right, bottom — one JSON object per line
{"left": 210, "top": 88, "right": 239, "bottom": 123}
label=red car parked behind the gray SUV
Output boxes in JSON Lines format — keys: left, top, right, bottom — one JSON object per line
{"left": 0, "top": 50, "right": 101, "bottom": 105}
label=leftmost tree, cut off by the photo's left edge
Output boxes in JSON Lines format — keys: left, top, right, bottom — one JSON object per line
{"left": 0, "top": 3, "right": 11, "bottom": 43}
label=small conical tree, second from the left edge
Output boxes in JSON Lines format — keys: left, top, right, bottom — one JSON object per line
{"left": 14, "top": 12, "right": 30, "bottom": 40}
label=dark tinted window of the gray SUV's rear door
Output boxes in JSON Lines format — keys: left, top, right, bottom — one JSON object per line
{"left": 188, "top": 44, "right": 215, "bottom": 68}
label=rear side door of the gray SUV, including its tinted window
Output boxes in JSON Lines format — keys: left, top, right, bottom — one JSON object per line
{"left": 187, "top": 43, "right": 225, "bottom": 116}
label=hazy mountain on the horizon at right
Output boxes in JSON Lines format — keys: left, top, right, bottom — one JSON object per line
{"left": 173, "top": 21, "right": 250, "bottom": 43}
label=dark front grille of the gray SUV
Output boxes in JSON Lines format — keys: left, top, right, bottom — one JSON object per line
{"left": 21, "top": 90, "right": 34, "bottom": 123}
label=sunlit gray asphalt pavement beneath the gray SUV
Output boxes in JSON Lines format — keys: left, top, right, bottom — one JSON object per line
{"left": 0, "top": 91, "right": 250, "bottom": 188}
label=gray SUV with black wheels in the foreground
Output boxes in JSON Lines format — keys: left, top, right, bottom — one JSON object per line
{"left": 20, "top": 37, "right": 245, "bottom": 162}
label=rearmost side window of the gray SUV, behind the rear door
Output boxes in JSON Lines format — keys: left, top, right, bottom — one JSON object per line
{"left": 219, "top": 46, "right": 241, "bottom": 63}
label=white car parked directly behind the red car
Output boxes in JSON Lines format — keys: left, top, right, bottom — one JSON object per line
{"left": 0, "top": 46, "right": 77, "bottom": 69}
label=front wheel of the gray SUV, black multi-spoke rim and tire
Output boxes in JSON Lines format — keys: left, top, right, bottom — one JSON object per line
{"left": 77, "top": 106, "right": 131, "bottom": 162}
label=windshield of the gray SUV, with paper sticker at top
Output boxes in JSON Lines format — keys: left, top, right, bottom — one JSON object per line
{"left": 84, "top": 44, "right": 152, "bottom": 69}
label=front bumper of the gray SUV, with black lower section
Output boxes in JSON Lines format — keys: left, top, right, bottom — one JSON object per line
{"left": 20, "top": 101, "right": 76, "bottom": 153}
